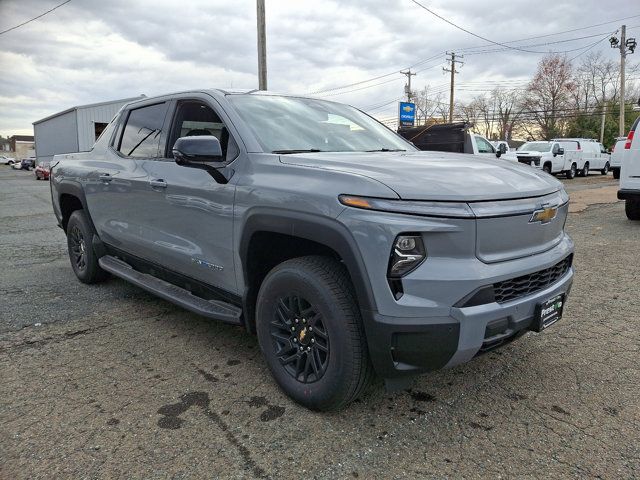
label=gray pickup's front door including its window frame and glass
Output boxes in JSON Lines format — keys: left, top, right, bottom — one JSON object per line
{"left": 143, "top": 99, "right": 239, "bottom": 293}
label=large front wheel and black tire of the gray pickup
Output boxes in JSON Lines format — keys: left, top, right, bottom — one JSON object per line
{"left": 256, "top": 256, "right": 373, "bottom": 411}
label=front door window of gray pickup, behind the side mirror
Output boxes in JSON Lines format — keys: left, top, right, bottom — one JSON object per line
{"left": 166, "top": 101, "right": 240, "bottom": 162}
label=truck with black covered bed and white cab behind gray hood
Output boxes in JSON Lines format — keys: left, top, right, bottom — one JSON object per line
{"left": 398, "top": 122, "right": 509, "bottom": 158}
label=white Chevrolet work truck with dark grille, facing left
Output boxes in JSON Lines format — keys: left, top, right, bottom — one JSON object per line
{"left": 515, "top": 141, "right": 584, "bottom": 179}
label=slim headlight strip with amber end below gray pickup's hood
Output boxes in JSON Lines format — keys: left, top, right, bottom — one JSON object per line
{"left": 338, "top": 195, "right": 475, "bottom": 218}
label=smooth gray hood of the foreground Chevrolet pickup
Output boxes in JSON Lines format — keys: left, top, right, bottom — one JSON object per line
{"left": 280, "top": 152, "right": 561, "bottom": 202}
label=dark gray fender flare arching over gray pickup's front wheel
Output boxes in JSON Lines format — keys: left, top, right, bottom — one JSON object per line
{"left": 239, "top": 207, "right": 376, "bottom": 316}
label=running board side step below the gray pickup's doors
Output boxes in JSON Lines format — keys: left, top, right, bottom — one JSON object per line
{"left": 98, "top": 255, "right": 242, "bottom": 325}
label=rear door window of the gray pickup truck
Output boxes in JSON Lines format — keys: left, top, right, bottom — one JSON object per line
{"left": 117, "top": 103, "right": 167, "bottom": 158}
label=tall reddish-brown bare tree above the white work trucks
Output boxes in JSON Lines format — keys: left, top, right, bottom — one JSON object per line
{"left": 524, "top": 54, "right": 575, "bottom": 140}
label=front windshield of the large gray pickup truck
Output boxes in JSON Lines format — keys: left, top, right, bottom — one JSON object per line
{"left": 227, "top": 94, "right": 416, "bottom": 154}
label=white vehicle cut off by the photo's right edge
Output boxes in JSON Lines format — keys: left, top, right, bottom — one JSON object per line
{"left": 618, "top": 117, "right": 640, "bottom": 220}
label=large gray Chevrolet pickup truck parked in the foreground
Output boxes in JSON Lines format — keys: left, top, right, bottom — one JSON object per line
{"left": 51, "top": 90, "right": 573, "bottom": 410}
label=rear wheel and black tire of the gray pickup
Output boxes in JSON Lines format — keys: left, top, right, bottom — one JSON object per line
{"left": 67, "top": 210, "right": 109, "bottom": 283}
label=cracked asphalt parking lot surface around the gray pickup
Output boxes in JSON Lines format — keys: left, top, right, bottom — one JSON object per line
{"left": 0, "top": 167, "right": 640, "bottom": 479}
